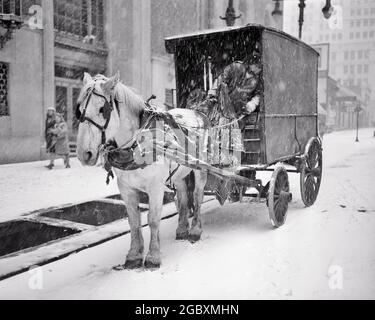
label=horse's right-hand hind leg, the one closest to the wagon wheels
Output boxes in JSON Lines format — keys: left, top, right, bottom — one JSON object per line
{"left": 189, "top": 170, "right": 207, "bottom": 243}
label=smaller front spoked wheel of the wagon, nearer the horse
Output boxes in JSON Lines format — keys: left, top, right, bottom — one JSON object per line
{"left": 267, "top": 166, "right": 291, "bottom": 228}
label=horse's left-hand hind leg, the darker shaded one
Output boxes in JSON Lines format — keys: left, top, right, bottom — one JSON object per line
{"left": 174, "top": 179, "right": 189, "bottom": 240}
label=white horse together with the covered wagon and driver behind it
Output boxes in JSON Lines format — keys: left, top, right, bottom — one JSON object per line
{"left": 76, "top": 25, "right": 322, "bottom": 269}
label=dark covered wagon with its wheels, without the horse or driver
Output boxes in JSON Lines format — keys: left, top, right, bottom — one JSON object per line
{"left": 165, "top": 25, "right": 322, "bottom": 227}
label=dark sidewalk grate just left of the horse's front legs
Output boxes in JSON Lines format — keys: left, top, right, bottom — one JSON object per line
{"left": 41, "top": 201, "right": 127, "bottom": 226}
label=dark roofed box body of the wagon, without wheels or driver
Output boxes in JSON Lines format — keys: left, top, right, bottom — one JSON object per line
{"left": 165, "top": 24, "right": 319, "bottom": 167}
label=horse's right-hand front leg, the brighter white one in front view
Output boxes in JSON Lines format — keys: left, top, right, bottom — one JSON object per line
{"left": 145, "top": 185, "right": 164, "bottom": 269}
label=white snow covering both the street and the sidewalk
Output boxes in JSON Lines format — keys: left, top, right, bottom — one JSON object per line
{"left": 0, "top": 129, "right": 375, "bottom": 299}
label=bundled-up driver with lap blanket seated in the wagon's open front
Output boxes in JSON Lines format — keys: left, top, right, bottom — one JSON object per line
{"left": 189, "top": 43, "right": 261, "bottom": 167}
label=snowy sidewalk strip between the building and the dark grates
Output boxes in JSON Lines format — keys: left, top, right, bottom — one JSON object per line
{"left": 0, "top": 159, "right": 119, "bottom": 222}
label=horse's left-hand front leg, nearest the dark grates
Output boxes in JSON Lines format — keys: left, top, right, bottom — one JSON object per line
{"left": 119, "top": 183, "right": 144, "bottom": 269}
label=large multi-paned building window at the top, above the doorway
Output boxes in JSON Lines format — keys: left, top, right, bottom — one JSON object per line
{"left": 54, "top": 0, "right": 104, "bottom": 42}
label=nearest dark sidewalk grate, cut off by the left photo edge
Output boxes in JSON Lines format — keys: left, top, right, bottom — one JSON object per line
{"left": 0, "top": 220, "right": 80, "bottom": 257}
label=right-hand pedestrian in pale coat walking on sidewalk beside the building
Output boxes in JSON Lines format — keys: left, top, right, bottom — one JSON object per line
{"left": 47, "top": 113, "right": 70, "bottom": 170}
